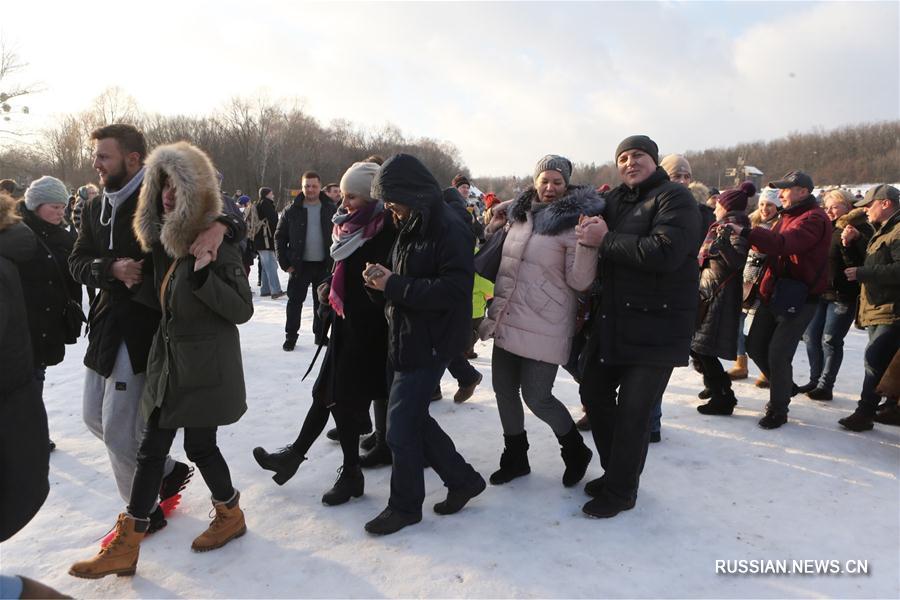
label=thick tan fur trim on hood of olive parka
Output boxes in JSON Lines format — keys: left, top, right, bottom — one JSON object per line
{"left": 133, "top": 142, "right": 222, "bottom": 258}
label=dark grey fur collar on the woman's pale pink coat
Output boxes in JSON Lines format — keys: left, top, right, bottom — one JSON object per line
{"left": 509, "top": 185, "right": 606, "bottom": 235}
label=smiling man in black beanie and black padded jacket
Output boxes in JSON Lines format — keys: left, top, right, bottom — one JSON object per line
{"left": 576, "top": 135, "right": 700, "bottom": 517}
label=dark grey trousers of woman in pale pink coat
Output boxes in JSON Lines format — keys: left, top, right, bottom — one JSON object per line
{"left": 491, "top": 344, "right": 575, "bottom": 437}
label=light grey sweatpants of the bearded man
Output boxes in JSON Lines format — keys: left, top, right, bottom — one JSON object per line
{"left": 83, "top": 342, "right": 175, "bottom": 504}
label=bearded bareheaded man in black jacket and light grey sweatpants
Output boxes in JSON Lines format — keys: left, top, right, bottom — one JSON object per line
{"left": 69, "top": 124, "right": 245, "bottom": 531}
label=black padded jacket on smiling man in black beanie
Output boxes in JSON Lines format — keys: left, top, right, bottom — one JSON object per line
{"left": 585, "top": 168, "right": 701, "bottom": 366}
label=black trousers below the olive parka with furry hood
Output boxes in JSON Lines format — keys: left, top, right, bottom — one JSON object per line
{"left": 128, "top": 409, "right": 234, "bottom": 519}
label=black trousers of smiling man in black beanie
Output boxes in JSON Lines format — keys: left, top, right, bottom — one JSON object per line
{"left": 579, "top": 363, "right": 672, "bottom": 498}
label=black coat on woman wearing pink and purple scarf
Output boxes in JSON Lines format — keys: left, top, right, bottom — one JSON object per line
{"left": 313, "top": 214, "right": 397, "bottom": 411}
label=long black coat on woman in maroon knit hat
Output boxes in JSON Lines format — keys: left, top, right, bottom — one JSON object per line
{"left": 691, "top": 211, "right": 750, "bottom": 360}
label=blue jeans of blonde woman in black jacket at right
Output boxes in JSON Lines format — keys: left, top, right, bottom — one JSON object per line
{"left": 803, "top": 302, "right": 856, "bottom": 391}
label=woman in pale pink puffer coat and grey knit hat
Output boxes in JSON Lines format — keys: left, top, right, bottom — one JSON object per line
{"left": 479, "top": 155, "right": 605, "bottom": 486}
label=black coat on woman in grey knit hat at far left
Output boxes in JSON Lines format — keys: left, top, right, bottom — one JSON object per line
{"left": 19, "top": 205, "right": 81, "bottom": 367}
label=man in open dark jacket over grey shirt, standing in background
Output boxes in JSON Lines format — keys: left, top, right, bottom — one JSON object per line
{"left": 275, "top": 171, "right": 336, "bottom": 352}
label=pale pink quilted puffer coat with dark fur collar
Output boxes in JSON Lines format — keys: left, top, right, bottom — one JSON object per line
{"left": 479, "top": 192, "right": 604, "bottom": 365}
